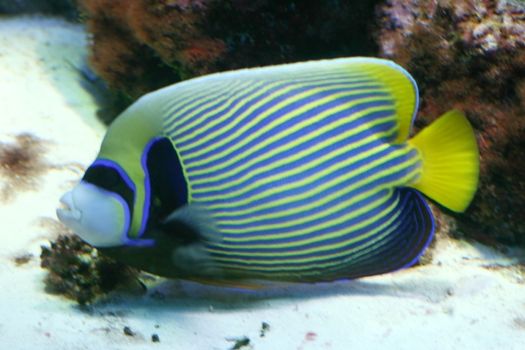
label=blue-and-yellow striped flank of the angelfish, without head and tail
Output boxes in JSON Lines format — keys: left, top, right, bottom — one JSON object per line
{"left": 157, "top": 59, "right": 433, "bottom": 280}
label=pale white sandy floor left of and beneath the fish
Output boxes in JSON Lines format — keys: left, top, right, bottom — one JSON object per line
{"left": 0, "top": 18, "right": 525, "bottom": 350}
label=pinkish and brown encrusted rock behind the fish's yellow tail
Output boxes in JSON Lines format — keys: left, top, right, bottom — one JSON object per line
{"left": 377, "top": 0, "right": 525, "bottom": 245}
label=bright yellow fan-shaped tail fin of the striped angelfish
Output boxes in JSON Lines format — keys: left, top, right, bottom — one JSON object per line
{"left": 408, "top": 110, "right": 479, "bottom": 212}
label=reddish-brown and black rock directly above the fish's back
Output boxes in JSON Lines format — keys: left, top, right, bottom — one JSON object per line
{"left": 79, "top": 0, "right": 378, "bottom": 98}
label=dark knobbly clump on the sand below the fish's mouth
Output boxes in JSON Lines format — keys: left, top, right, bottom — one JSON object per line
{"left": 40, "top": 235, "right": 138, "bottom": 305}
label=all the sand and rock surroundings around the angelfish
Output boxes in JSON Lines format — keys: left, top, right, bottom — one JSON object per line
{"left": 0, "top": 0, "right": 525, "bottom": 349}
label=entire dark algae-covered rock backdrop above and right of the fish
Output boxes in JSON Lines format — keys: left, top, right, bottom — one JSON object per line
{"left": 78, "top": 0, "right": 525, "bottom": 244}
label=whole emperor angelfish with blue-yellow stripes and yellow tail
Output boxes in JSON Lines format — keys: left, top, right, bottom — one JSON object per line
{"left": 57, "top": 57, "right": 479, "bottom": 283}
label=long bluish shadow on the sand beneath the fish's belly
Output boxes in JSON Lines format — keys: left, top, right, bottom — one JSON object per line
{"left": 83, "top": 272, "right": 451, "bottom": 314}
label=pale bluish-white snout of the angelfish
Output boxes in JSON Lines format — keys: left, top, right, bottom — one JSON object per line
{"left": 57, "top": 181, "right": 130, "bottom": 247}
